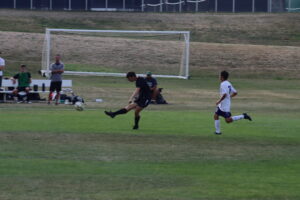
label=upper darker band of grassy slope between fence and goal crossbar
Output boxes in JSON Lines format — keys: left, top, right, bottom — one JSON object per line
{"left": 0, "top": 10, "right": 300, "bottom": 46}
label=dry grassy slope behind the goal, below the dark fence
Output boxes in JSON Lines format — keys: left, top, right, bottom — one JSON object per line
{"left": 0, "top": 10, "right": 300, "bottom": 79}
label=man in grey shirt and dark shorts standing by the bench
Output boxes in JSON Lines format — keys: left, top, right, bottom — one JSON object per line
{"left": 48, "top": 54, "right": 64, "bottom": 105}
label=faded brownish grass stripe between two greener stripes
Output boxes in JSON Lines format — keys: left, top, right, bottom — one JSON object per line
{"left": 0, "top": 133, "right": 300, "bottom": 162}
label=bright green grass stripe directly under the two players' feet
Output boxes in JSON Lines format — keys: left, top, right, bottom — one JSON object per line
{"left": 0, "top": 109, "right": 300, "bottom": 142}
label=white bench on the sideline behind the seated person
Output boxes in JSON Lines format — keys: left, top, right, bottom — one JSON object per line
{"left": 0, "top": 79, "right": 72, "bottom": 102}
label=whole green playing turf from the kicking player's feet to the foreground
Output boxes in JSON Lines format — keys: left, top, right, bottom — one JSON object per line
{"left": 0, "top": 108, "right": 300, "bottom": 200}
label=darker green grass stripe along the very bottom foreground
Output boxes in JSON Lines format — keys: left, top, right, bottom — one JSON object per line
{"left": 0, "top": 160, "right": 300, "bottom": 199}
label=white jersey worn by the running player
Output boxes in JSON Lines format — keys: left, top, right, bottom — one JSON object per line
{"left": 218, "top": 81, "right": 236, "bottom": 112}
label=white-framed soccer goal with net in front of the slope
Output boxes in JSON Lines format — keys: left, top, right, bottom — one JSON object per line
{"left": 41, "top": 29, "right": 190, "bottom": 79}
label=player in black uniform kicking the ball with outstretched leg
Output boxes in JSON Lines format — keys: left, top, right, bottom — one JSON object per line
{"left": 104, "top": 72, "right": 151, "bottom": 129}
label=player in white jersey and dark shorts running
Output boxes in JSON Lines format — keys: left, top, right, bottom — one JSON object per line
{"left": 214, "top": 71, "right": 252, "bottom": 135}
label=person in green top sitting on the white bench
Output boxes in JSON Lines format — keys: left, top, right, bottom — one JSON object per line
{"left": 11, "top": 65, "right": 31, "bottom": 103}
